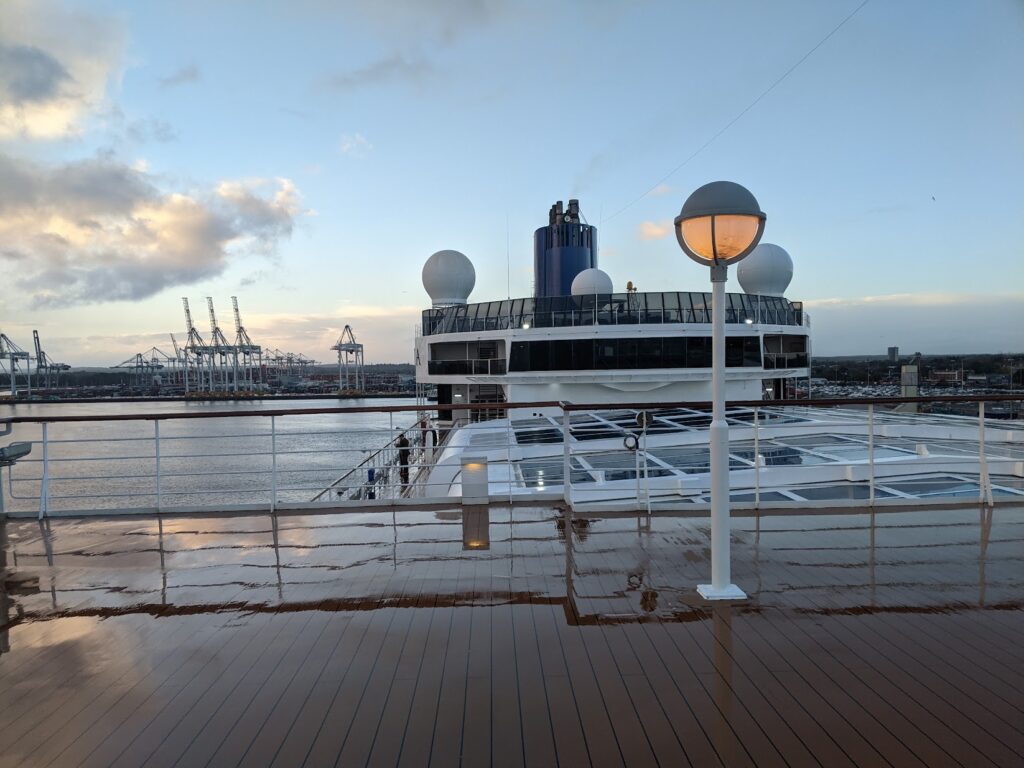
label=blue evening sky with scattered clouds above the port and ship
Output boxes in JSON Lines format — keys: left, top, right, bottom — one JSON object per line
{"left": 0, "top": 0, "right": 1024, "bottom": 366}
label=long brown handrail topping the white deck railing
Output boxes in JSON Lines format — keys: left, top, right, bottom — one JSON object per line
{"left": 2, "top": 392, "right": 1024, "bottom": 424}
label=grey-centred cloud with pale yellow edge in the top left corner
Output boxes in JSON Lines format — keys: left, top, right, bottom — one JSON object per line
{"left": 0, "top": 0, "right": 124, "bottom": 138}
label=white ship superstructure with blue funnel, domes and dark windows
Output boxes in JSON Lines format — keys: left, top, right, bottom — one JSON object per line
{"left": 416, "top": 200, "right": 811, "bottom": 421}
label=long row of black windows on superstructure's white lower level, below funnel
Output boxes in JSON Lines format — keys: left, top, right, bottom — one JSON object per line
{"left": 508, "top": 336, "right": 761, "bottom": 372}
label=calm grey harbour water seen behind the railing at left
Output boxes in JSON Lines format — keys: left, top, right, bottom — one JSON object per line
{"left": 0, "top": 398, "right": 416, "bottom": 512}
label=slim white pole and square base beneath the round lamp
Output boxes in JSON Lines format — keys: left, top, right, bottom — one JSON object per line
{"left": 697, "top": 265, "right": 746, "bottom": 600}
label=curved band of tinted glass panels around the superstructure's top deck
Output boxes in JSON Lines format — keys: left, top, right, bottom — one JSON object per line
{"left": 423, "top": 292, "right": 804, "bottom": 336}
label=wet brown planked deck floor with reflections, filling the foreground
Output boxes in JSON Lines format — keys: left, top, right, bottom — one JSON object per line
{"left": 0, "top": 507, "right": 1024, "bottom": 768}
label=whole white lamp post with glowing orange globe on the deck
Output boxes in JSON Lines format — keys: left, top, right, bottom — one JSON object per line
{"left": 676, "top": 181, "right": 765, "bottom": 600}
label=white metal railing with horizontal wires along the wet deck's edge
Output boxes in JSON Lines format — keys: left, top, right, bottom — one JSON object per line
{"left": 0, "top": 395, "right": 1024, "bottom": 517}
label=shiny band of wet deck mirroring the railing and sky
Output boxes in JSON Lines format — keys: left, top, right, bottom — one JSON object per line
{"left": 0, "top": 506, "right": 1024, "bottom": 647}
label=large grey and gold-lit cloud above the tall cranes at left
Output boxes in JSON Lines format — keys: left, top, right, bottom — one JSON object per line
{"left": 0, "top": 154, "right": 301, "bottom": 307}
